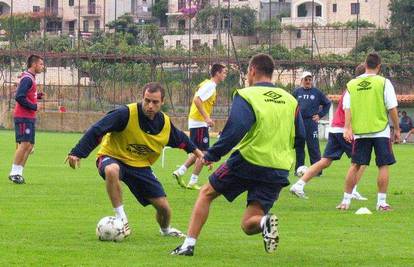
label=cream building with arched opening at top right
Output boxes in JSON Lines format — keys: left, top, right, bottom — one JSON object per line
{"left": 282, "top": 0, "right": 390, "bottom": 28}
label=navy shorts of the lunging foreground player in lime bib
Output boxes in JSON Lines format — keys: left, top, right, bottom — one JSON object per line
{"left": 210, "top": 163, "right": 284, "bottom": 214}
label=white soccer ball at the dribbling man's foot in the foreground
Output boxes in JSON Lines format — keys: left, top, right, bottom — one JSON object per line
{"left": 96, "top": 216, "right": 125, "bottom": 242}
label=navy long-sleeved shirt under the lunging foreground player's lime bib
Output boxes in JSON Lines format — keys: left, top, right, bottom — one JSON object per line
{"left": 204, "top": 83, "right": 305, "bottom": 185}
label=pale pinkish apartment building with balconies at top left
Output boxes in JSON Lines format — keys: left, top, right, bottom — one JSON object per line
{"left": 0, "top": 0, "right": 153, "bottom": 35}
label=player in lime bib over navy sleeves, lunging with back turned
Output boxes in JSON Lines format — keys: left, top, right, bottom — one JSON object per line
{"left": 171, "top": 54, "right": 305, "bottom": 256}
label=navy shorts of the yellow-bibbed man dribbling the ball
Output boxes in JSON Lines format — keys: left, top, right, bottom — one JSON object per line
{"left": 96, "top": 156, "right": 166, "bottom": 206}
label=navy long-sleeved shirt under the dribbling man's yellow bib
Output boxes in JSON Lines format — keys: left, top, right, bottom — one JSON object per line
{"left": 69, "top": 103, "right": 196, "bottom": 158}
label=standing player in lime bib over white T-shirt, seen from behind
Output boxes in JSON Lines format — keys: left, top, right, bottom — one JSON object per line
{"left": 337, "top": 53, "right": 400, "bottom": 211}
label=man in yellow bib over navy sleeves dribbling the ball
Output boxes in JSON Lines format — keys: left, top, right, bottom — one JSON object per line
{"left": 66, "top": 83, "right": 203, "bottom": 240}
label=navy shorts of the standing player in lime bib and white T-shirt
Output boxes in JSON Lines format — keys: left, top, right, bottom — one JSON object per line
{"left": 352, "top": 137, "right": 396, "bottom": 166}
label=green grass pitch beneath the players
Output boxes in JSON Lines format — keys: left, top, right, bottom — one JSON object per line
{"left": 0, "top": 131, "right": 414, "bottom": 266}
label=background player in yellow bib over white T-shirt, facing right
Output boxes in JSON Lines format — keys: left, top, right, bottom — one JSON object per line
{"left": 173, "top": 64, "right": 227, "bottom": 190}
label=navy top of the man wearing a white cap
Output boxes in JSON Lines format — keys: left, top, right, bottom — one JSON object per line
{"left": 292, "top": 87, "right": 331, "bottom": 119}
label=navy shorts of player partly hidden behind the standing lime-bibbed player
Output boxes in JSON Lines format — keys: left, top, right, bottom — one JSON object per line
{"left": 323, "top": 133, "right": 352, "bottom": 160}
